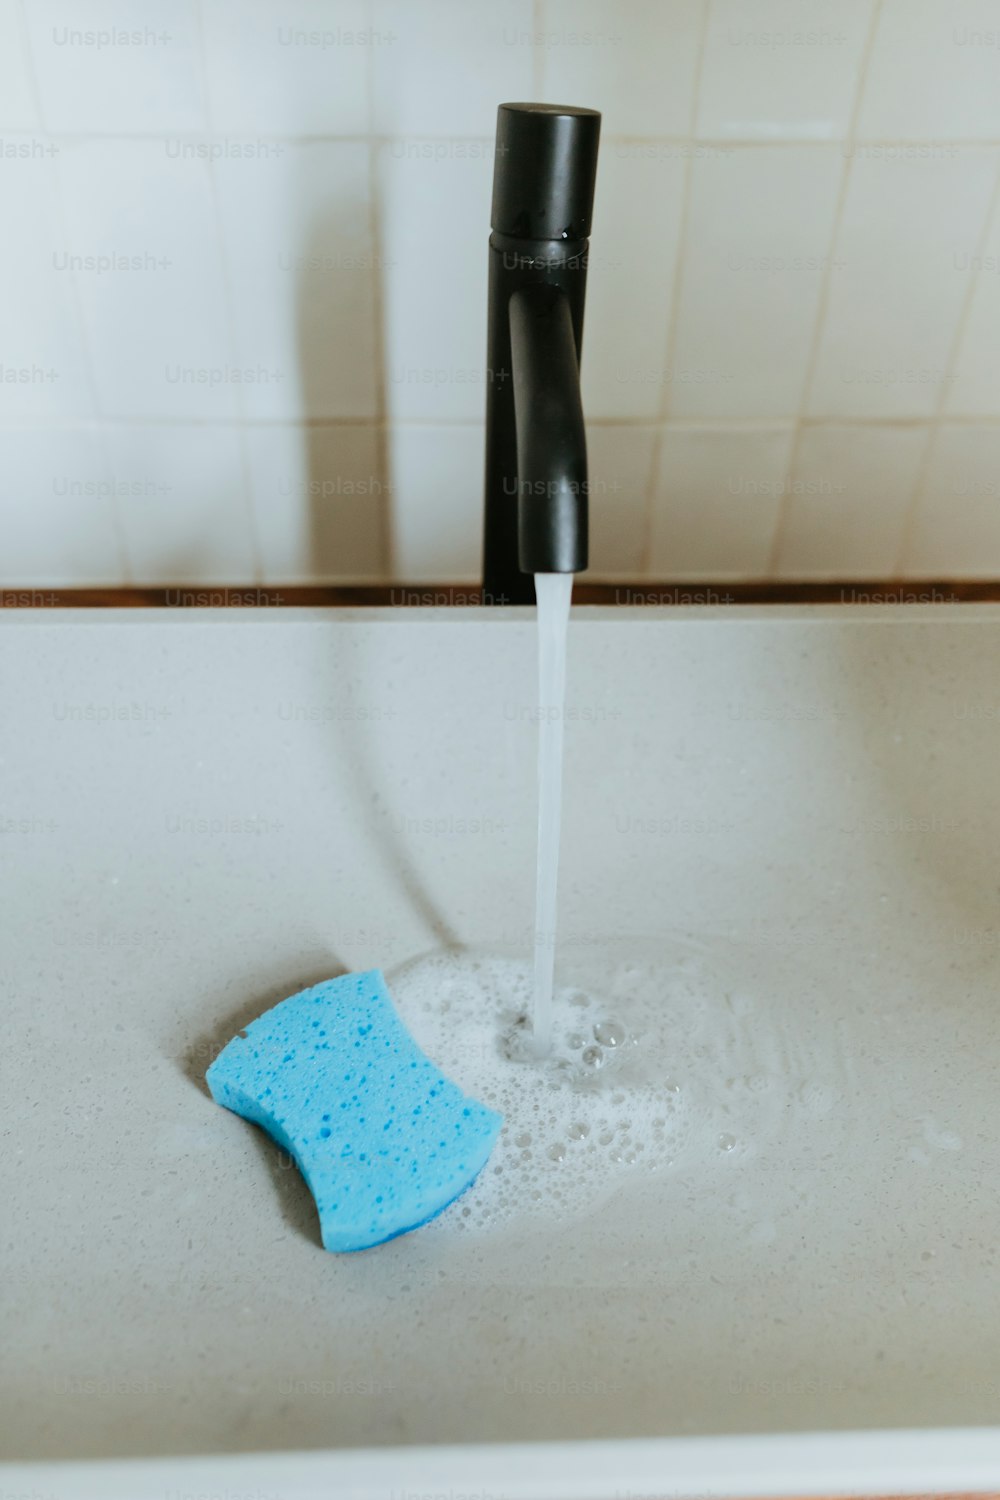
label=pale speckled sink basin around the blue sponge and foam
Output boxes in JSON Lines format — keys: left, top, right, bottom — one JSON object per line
{"left": 0, "top": 605, "right": 1000, "bottom": 1500}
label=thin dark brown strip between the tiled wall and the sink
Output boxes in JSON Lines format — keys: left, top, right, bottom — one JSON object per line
{"left": 0, "top": 579, "right": 1000, "bottom": 609}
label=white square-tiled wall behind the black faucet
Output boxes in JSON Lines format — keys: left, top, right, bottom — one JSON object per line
{"left": 0, "top": 0, "right": 1000, "bottom": 587}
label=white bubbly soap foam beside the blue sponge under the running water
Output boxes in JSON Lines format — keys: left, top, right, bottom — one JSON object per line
{"left": 388, "top": 953, "right": 710, "bottom": 1232}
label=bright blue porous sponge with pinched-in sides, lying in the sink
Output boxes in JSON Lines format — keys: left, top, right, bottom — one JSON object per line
{"left": 205, "top": 969, "right": 502, "bottom": 1250}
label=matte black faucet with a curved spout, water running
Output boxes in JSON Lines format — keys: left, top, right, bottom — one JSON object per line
{"left": 483, "top": 104, "right": 601, "bottom": 605}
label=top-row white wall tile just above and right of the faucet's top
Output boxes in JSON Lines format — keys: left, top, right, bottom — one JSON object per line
{"left": 538, "top": 0, "right": 703, "bottom": 137}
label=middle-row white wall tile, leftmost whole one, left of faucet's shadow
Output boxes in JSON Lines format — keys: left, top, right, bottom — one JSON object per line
{"left": 58, "top": 141, "right": 236, "bottom": 419}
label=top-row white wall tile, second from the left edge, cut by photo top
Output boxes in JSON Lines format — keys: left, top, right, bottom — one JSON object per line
{"left": 24, "top": 0, "right": 205, "bottom": 134}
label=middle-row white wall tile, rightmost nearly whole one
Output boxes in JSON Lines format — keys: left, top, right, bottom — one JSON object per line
{"left": 810, "top": 146, "right": 997, "bottom": 417}
